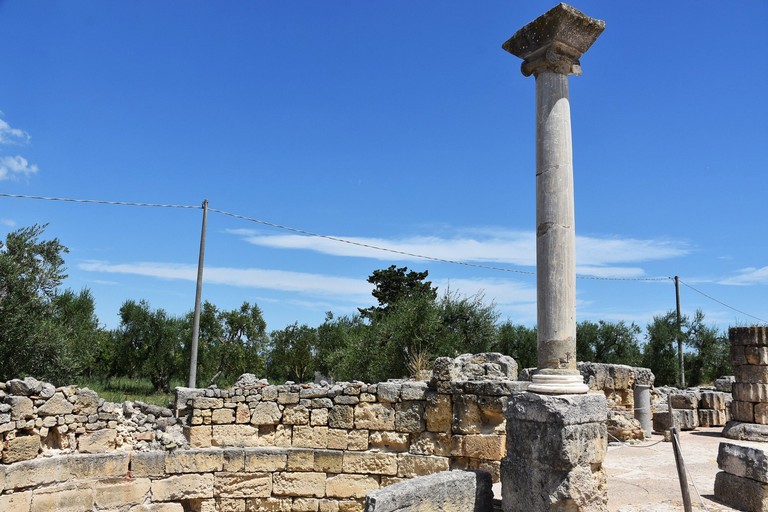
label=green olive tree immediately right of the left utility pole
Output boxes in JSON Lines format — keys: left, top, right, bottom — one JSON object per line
{"left": 195, "top": 301, "right": 268, "bottom": 385}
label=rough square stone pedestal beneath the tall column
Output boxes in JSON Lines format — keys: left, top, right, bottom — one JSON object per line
{"left": 501, "top": 392, "right": 608, "bottom": 512}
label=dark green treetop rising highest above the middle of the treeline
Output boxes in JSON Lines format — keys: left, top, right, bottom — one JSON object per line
{"left": 359, "top": 265, "right": 437, "bottom": 320}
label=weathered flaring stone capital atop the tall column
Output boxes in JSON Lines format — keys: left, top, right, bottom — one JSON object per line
{"left": 501, "top": 3, "right": 605, "bottom": 76}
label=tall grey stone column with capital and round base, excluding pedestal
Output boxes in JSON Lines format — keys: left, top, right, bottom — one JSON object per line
{"left": 503, "top": 4, "right": 605, "bottom": 394}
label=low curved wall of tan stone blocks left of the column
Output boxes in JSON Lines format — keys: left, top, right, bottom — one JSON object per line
{"left": 0, "top": 354, "right": 527, "bottom": 512}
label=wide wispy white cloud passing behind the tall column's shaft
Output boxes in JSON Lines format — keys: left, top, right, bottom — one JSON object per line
{"left": 229, "top": 228, "right": 690, "bottom": 277}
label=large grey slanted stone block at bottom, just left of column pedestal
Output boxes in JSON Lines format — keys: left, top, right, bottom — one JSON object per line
{"left": 365, "top": 471, "right": 492, "bottom": 512}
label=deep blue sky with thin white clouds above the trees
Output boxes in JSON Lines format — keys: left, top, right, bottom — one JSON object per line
{"left": 0, "top": 0, "right": 768, "bottom": 330}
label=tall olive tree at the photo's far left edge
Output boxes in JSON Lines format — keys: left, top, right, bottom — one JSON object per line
{"left": 0, "top": 225, "right": 74, "bottom": 383}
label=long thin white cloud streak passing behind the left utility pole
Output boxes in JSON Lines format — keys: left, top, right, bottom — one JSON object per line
{"left": 78, "top": 260, "right": 371, "bottom": 300}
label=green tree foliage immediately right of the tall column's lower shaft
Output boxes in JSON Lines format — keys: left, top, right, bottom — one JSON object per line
{"left": 576, "top": 320, "right": 642, "bottom": 366}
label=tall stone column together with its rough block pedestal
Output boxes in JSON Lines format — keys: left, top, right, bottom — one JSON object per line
{"left": 501, "top": 4, "right": 608, "bottom": 512}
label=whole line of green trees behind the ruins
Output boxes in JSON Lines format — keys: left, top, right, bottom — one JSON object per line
{"left": 0, "top": 225, "right": 731, "bottom": 392}
